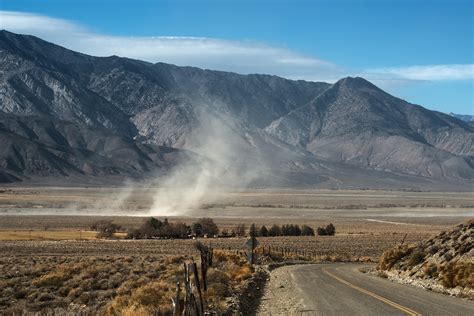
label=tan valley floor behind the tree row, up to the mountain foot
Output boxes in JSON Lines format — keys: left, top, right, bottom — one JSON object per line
{"left": 0, "top": 188, "right": 474, "bottom": 240}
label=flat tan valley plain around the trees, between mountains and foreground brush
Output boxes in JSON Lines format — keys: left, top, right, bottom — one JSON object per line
{"left": 0, "top": 188, "right": 474, "bottom": 259}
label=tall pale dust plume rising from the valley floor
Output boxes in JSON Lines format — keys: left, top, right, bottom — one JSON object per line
{"left": 150, "top": 113, "right": 261, "bottom": 216}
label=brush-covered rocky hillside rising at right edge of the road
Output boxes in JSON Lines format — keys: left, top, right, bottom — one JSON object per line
{"left": 378, "top": 219, "right": 474, "bottom": 299}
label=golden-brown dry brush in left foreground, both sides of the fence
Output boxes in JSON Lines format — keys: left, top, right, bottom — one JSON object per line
{"left": 0, "top": 251, "right": 260, "bottom": 315}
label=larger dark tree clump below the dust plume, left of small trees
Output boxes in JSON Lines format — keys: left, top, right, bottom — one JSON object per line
{"left": 127, "top": 217, "right": 219, "bottom": 239}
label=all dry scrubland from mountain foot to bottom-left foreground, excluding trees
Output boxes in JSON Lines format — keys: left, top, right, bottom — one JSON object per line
{"left": 0, "top": 188, "right": 474, "bottom": 314}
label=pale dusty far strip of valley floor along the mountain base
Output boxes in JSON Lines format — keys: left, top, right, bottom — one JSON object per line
{"left": 0, "top": 188, "right": 474, "bottom": 217}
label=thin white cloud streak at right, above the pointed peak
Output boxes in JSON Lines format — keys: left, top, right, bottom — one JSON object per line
{"left": 364, "top": 64, "right": 474, "bottom": 81}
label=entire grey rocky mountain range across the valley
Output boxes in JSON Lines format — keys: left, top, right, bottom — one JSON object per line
{"left": 0, "top": 31, "right": 474, "bottom": 190}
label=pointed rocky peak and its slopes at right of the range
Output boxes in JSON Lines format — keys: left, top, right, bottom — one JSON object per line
{"left": 266, "top": 78, "right": 474, "bottom": 179}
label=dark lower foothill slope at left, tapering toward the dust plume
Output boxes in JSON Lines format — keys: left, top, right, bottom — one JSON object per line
{"left": 0, "top": 112, "right": 190, "bottom": 184}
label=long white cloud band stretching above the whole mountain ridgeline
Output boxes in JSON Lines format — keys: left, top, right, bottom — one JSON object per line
{"left": 0, "top": 11, "right": 474, "bottom": 88}
